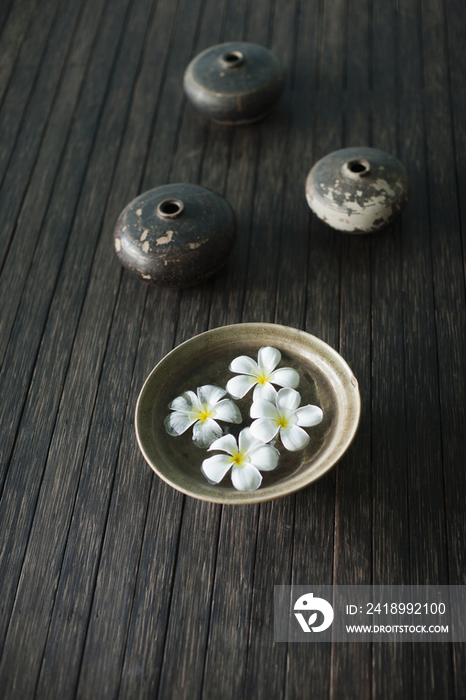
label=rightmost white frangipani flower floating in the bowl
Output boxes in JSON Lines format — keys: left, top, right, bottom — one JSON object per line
{"left": 250, "top": 388, "right": 323, "bottom": 452}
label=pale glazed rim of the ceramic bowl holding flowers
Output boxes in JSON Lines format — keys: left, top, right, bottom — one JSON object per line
{"left": 135, "top": 322, "right": 361, "bottom": 505}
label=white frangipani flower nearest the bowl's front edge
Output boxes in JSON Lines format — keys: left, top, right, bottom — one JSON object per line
{"left": 201, "top": 428, "right": 279, "bottom": 491}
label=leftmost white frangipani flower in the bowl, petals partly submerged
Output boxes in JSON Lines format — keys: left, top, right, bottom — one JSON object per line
{"left": 165, "top": 384, "right": 242, "bottom": 447}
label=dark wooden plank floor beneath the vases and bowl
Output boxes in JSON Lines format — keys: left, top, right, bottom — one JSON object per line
{"left": 0, "top": 0, "right": 466, "bottom": 700}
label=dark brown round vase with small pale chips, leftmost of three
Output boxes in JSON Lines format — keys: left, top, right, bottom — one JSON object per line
{"left": 114, "top": 184, "right": 236, "bottom": 288}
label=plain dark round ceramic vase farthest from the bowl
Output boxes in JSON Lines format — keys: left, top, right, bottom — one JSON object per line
{"left": 183, "top": 41, "right": 285, "bottom": 125}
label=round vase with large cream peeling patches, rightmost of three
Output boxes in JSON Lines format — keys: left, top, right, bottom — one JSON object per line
{"left": 306, "top": 148, "right": 410, "bottom": 233}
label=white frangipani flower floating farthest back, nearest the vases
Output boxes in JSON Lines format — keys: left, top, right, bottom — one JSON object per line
{"left": 227, "top": 347, "right": 299, "bottom": 401}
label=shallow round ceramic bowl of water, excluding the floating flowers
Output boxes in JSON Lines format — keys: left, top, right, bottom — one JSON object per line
{"left": 135, "top": 323, "right": 361, "bottom": 504}
